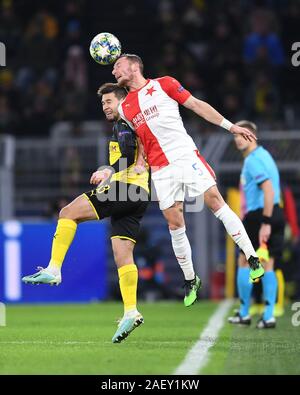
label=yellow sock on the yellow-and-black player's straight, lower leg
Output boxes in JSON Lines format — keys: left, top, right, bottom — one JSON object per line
{"left": 118, "top": 264, "right": 138, "bottom": 313}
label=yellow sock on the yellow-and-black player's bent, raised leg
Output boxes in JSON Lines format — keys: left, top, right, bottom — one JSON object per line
{"left": 48, "top": 218, "right": 77, "bottom": 271}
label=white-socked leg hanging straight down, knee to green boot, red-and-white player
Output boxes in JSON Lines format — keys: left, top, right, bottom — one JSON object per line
{"left": 163, "top": 202, "right": 201, "bottom": 307}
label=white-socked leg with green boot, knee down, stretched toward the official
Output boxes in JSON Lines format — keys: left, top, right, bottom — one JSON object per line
{"left": 204, "top": 185, "right": 264, "bottom": 281}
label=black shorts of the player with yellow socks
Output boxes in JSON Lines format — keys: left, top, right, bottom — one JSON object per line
{"left": 85, "top": 182, "right": 149, "bottom": 243}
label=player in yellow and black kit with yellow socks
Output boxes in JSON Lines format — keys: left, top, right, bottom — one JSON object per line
{"left": 22, "top": 83, "right": 149, "bottom": 343}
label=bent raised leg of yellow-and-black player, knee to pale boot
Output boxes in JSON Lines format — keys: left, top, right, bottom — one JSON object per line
{"left": 22, "top": 195, "right": 98, "bottom": 285}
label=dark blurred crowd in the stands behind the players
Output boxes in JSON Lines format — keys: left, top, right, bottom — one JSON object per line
{"left": 0, "top": 0, "right": 300, "bottom": 137}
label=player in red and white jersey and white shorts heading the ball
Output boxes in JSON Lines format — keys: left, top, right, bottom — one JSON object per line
{"left": 112, "top": 54, "right": 264, "bottom": 306}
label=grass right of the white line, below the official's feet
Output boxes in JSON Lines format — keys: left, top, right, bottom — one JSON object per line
{"left": 201, "top": 306, "right": 300, "bottom": 375}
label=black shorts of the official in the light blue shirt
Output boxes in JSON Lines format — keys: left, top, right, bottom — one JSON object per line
{"left": 243, "top": 204, "right": 285, "bottom": 267}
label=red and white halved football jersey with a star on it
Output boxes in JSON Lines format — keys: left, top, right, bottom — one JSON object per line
{"left": 119, "top": 77, "right": 197, "bottom": 168}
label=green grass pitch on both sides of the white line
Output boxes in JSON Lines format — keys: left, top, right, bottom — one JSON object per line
{"left": 0, "top": 302, "right": 300, "bottom": 375}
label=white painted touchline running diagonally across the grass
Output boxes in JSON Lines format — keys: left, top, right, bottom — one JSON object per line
{"left": 174, "top": 299, "right": 234, "bottom": 375}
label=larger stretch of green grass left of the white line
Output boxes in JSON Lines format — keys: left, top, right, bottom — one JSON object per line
{"left": 0, "top": 303, "right": 216, "bottom": 375}
